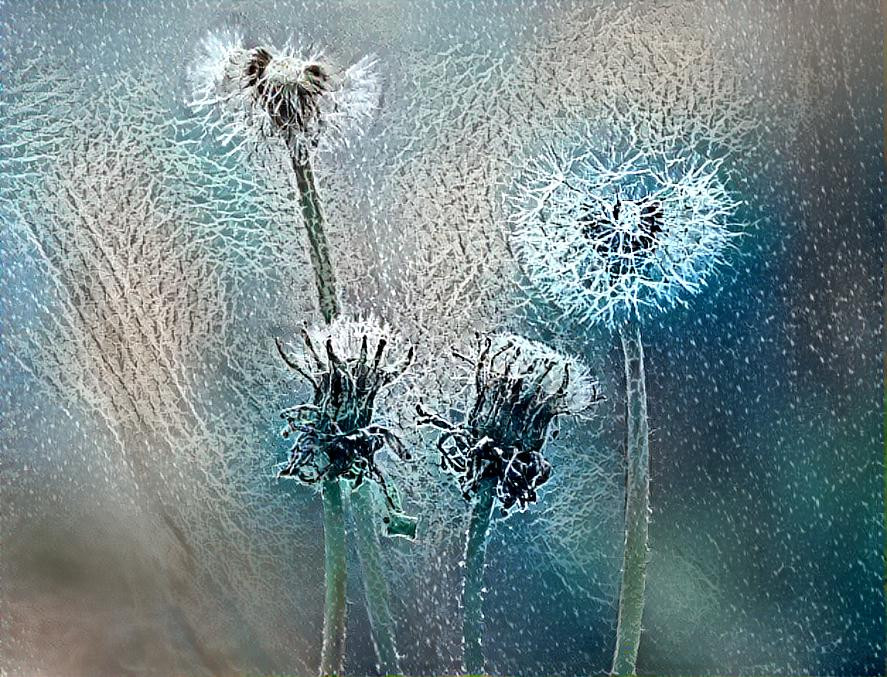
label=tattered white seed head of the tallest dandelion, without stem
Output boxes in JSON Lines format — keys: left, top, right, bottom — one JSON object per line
{"left": 190, "top": 32, "right": 382, "bottom": 160}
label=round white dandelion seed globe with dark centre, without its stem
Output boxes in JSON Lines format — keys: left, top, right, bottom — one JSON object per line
{"left": 507, "top": 127, "right": 740, "bottom": 328}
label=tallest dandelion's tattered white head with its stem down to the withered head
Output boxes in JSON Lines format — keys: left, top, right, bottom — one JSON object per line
{"left": 190, "top": 32, "right": 381, "bottom": 322}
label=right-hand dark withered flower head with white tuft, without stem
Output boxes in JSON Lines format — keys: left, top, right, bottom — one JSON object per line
{"left": 417, "top": 335, "right": 601, "bottom": 514}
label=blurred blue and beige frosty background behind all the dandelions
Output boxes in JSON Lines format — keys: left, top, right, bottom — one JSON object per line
{"left": 0, "top": 0, "right": 885, "bottom": 676}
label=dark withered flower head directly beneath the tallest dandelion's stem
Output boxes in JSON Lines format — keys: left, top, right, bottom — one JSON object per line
{"left": 277, "top": 319, "right": 415, "bottom": 535}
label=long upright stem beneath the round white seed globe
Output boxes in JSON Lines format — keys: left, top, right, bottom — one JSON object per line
{"left": 611, "top": 323, "right": 650, "bottom": 675}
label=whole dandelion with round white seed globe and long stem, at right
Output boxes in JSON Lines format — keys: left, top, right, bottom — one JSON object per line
{"left": 510, "top": 128, "right": 740, "bottom": 674}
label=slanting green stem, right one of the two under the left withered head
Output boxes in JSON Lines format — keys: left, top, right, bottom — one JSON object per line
{"left": 351, "top": 483, "right": 400, "bottom": 675}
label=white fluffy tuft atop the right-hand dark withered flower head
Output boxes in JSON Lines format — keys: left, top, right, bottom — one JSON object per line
{"left": 487, "top": 334, "right": 600, "bottom": 415}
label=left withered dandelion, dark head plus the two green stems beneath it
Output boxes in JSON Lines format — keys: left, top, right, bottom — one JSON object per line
{"left": 277, "top": 318, "right": 416, "bottom": 675}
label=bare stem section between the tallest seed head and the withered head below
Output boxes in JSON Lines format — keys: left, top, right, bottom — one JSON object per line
{"left": 292, "top": 156, "right": 339, "bottom": 322}
